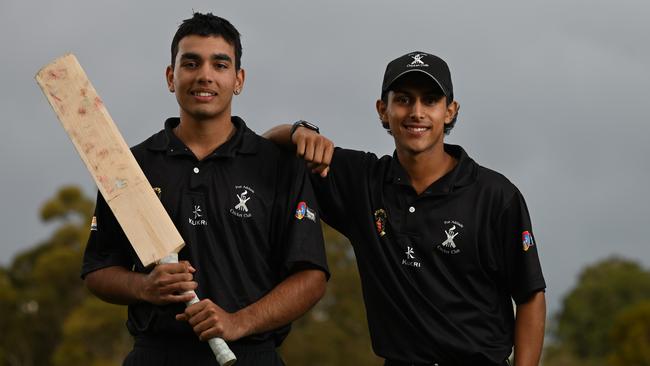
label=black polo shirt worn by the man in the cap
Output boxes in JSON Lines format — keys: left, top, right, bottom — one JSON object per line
{"left": 312, "top": 145, "right": 546, "bottom": 366}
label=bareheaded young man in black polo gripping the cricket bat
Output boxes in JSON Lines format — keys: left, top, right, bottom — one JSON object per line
{"left": 82, "top": 13, "right": 328, "bottom": 366}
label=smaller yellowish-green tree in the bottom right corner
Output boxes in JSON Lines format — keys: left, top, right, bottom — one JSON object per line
{"left": 608, "top": 300, "right": 650, "bottom": 366}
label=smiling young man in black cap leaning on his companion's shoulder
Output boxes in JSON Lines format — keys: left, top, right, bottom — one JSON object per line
{"left": 265, "top": 52, "right": 546, "bottom": 366}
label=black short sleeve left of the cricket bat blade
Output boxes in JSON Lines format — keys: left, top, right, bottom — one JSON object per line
{"left": 81, "top": 193, "right": 135, "bottom": 278}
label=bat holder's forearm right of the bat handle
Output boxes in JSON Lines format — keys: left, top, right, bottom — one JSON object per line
{"left": 235, "top": 270, "right": 326, "bottom": 336}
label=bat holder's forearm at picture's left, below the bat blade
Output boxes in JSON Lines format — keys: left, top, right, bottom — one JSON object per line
{"left": 85, "top": 266, "right": 145, "bottom": 305}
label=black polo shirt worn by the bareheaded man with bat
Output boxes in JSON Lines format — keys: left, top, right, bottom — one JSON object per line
{"left": 82, "top": 117, "right": 329, "bottom": 345}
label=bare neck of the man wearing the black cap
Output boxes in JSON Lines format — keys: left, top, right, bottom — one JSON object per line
{"left": 397, "top": 146, "right": 457, "bottom": 194}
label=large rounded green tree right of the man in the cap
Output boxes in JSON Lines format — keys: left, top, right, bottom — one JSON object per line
{"left": 545, "top": 258, "right": 650, "bottom": 365}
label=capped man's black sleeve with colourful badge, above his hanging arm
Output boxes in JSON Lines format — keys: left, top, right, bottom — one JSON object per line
{"left": 499, "top": 190, "right": 546, "bottom": 304}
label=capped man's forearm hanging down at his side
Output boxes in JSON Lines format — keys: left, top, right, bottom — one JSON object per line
{"left": 515, "top": 291, "right": 546, "bottom": 366}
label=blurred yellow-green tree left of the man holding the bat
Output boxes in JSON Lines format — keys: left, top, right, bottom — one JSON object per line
{"left": 0, "top": 186, "right": 109, "bottom": 366}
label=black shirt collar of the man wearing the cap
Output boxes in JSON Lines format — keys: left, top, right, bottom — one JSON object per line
{"left": 386, "top": 144, "right": 478, "bottom": 194}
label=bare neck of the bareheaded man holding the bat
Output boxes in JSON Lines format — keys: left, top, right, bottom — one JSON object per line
{"left": 174, "top": 111, "right": 235, "bottom": 160}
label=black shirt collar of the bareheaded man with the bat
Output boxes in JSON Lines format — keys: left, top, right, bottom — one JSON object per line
{"left": 147, "top": 116, "right": 258, "bottom": 159}
